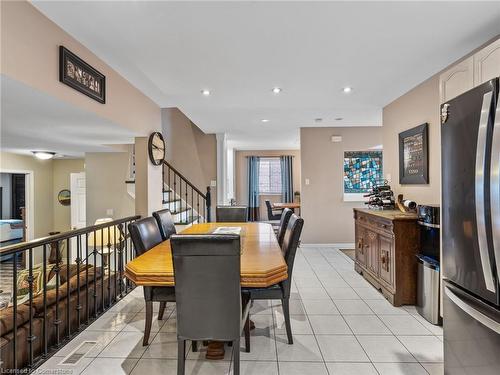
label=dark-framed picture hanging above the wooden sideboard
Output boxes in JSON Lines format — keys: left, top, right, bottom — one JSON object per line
{"left": 399, "top": 123, "right": 429, "bottom": 185}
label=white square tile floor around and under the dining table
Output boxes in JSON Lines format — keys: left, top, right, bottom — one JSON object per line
{"left": 42, "top": 248, "right": 443, "bottom": 375}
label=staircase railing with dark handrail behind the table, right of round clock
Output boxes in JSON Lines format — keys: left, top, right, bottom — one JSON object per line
{"left": 162, "top": 160, "right": 212, "bottom": 225}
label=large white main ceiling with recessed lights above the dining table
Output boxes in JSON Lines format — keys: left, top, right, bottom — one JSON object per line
{"left": 30, "top": 1, "right": 500, "bottom": 148}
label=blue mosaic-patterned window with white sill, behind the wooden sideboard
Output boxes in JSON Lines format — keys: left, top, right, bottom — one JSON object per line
{"left": 344, "top": 151, "right": 383, "bottom": 200}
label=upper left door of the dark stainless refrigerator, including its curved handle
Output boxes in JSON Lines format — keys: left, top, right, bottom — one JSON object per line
{"left": 441, "top": 80, "right": 498, "bottom": 304}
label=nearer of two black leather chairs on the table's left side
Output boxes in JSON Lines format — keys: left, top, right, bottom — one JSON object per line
{"left": 128, "top": 217, "right": 175, "bottom": 346}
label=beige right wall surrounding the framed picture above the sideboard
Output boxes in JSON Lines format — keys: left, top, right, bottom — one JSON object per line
{"left": 382, "top": 75, "right": 441, "bottom": 204}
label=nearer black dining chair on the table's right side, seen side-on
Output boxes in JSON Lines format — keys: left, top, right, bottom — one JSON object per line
{"left": 242, "top": 214, "right": 304, "bottom": 346}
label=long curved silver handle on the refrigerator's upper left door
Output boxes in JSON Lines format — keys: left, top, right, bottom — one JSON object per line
{"left": 475, "top": 91, "right": 496, "bottom": 293}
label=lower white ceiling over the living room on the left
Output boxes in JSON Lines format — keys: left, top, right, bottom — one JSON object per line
{"left": 0, "top": 75, "right": 138, "bottom": 157}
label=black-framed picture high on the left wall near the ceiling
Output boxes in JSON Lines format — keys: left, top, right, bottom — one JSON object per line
{"left": 59, "top": 46, "right": 106, "bottom": 104}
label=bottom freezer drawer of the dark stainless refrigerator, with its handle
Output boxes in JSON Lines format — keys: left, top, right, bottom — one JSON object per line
{"left": 443, "top": 284, "right": 500, "bottom": 375}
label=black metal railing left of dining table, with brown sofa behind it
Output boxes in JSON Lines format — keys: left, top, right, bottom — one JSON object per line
{"left": 0, "top": 216, "right": 140, "bottom": 372}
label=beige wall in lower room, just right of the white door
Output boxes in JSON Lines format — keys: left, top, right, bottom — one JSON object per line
{"left": 85, "top": 152, "right": 135, "bottom": 225}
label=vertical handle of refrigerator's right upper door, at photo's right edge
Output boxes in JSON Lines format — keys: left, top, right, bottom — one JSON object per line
{"left": 490, "top": 95, "right": 500, "bottom": 278}
